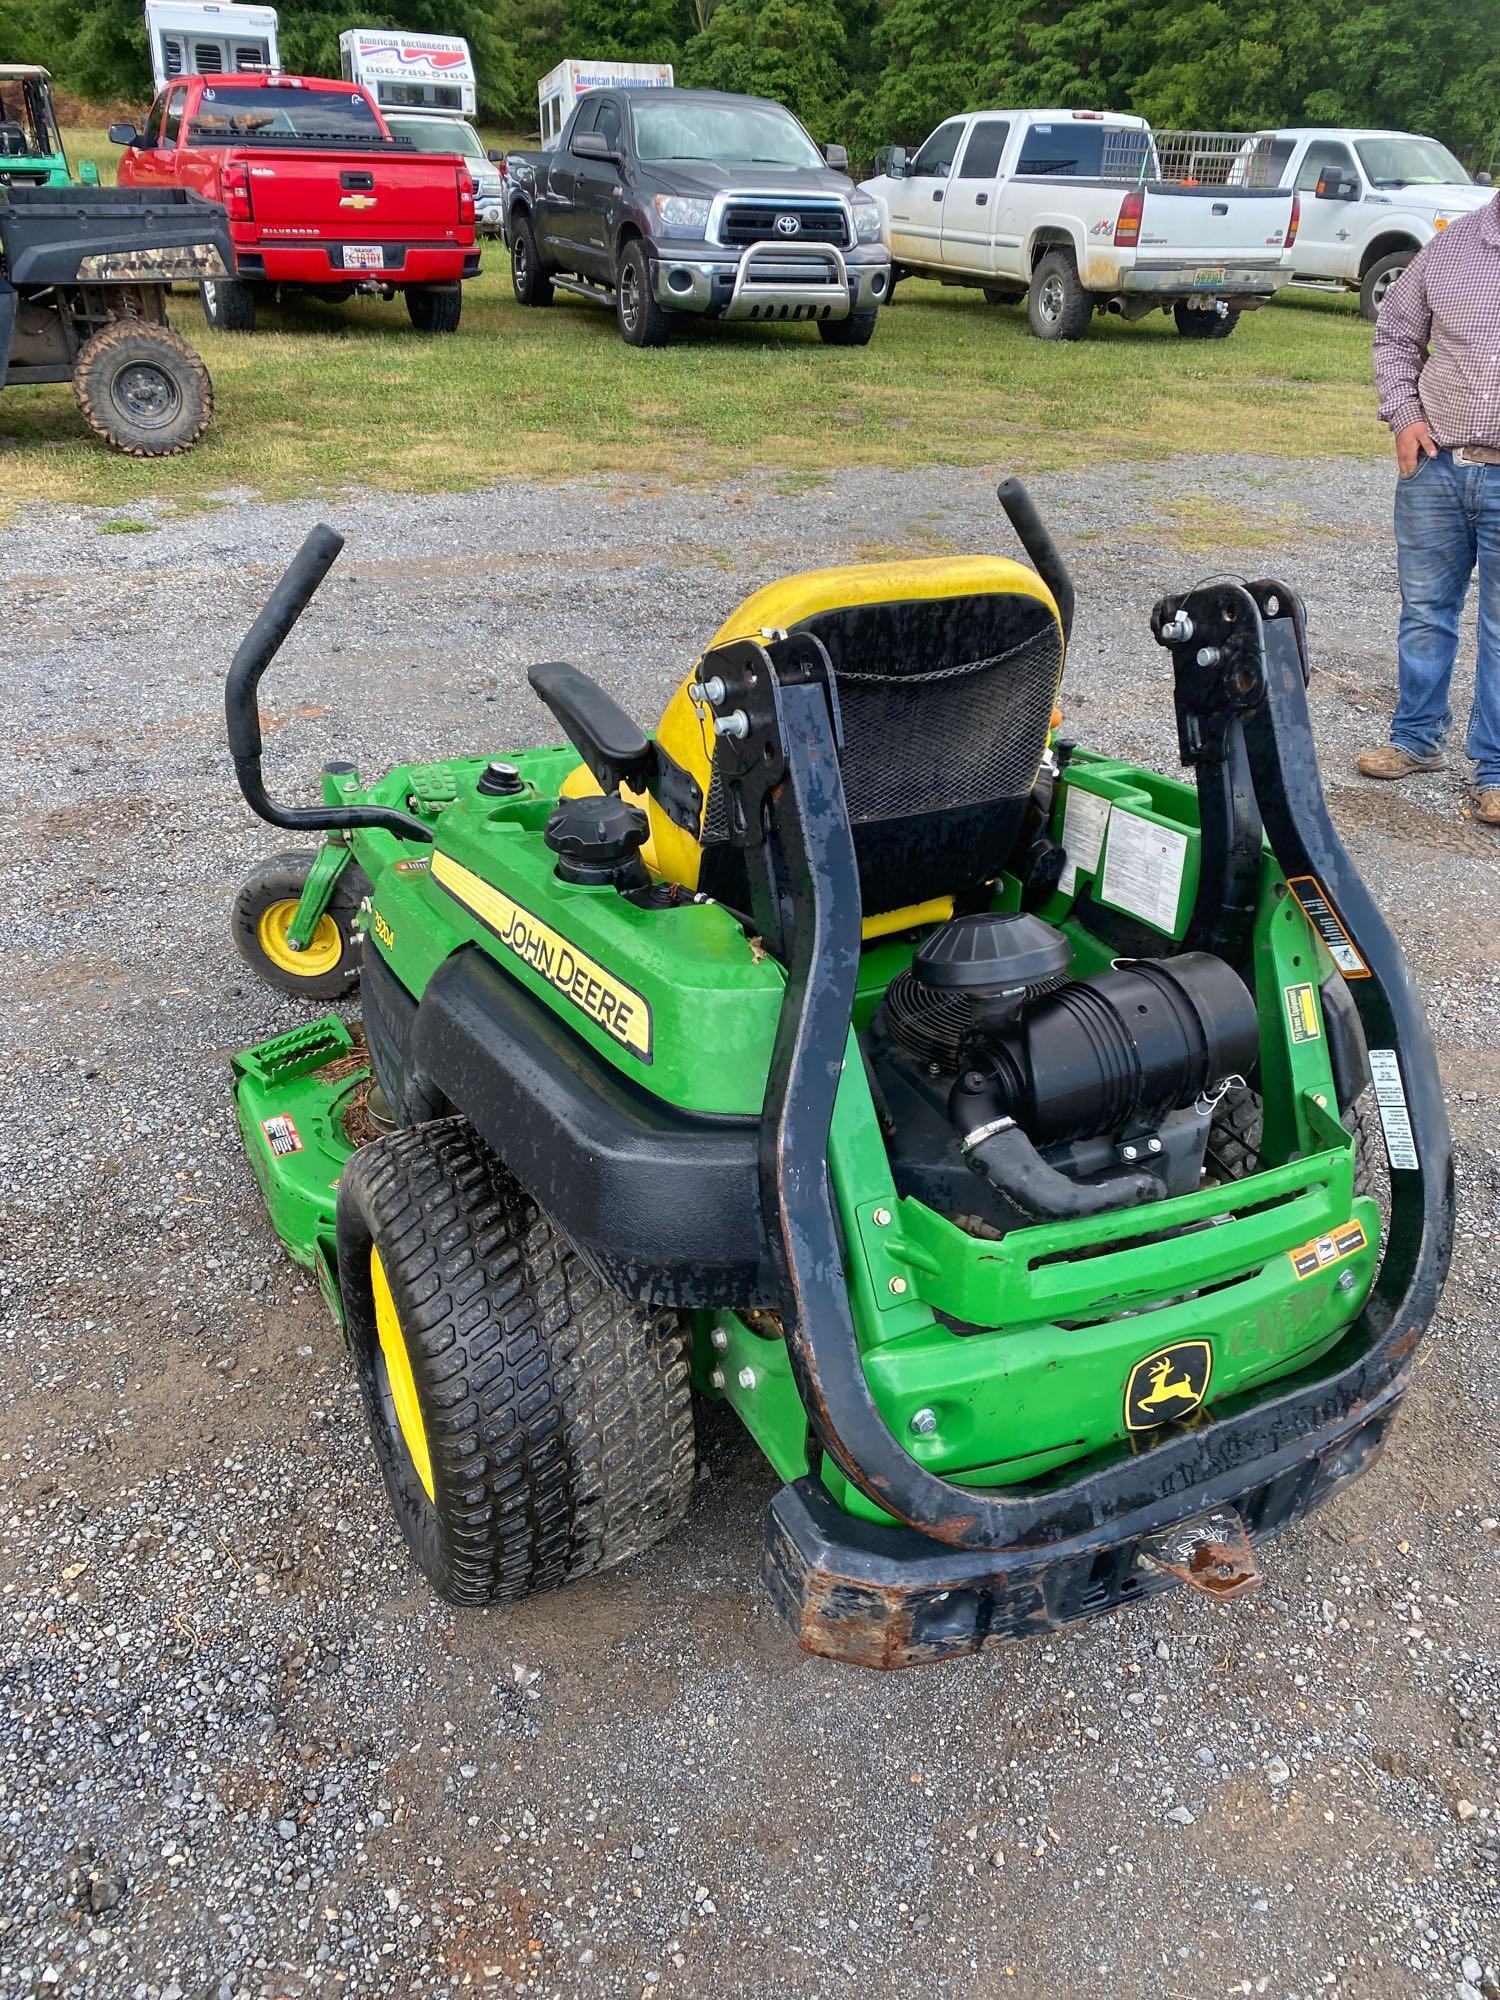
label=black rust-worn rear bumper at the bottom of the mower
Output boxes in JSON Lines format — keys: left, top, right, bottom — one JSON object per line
{"left": 762, "top": 1378, "right": 1406, "bottom": 1668}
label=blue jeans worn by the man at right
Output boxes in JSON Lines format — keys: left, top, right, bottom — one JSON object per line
{"left": 1390, "top": 452, "right": 1500, "bottom": 788}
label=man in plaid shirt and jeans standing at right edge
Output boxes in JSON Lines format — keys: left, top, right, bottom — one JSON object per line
{"left": 1358, "top": 194, "right": 1500, "bottom": 826}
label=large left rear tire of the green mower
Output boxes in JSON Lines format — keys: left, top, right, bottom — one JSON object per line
{"left": 338, "top": 1118, "right": 694, "bottom": 1604}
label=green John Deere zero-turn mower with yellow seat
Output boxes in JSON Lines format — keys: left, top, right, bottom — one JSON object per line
{"left": 226, "top": 480, "right": 1452, "bottom": 1666}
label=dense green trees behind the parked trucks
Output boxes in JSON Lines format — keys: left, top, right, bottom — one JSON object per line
{"left": 0, "top": 0, "right": 1500, "bottom": 168}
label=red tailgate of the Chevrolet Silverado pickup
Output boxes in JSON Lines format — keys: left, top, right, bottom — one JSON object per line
{"left": 240, "top": 148, "right": 458, "bottom": 244}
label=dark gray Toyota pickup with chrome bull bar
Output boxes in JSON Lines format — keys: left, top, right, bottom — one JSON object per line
{"left": 504, "top": 90, "right": 890, "bottom": 348}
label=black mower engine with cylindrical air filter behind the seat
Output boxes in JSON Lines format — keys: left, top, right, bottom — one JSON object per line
{"left": 866, "top": 912, "right": 1260, "bottom": 1234}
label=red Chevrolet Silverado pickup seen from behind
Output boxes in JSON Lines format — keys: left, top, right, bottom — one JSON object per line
{"left": 110, "top": 74, "right": 480, "bottom": 334}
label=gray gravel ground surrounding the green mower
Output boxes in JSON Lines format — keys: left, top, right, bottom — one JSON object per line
{"left": 0, "top": 460, "right": 1500, "bottom": 2000}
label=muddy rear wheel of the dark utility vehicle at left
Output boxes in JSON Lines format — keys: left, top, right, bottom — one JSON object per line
{"left": 72, "top": 320, "right": 214, "bottom": 458}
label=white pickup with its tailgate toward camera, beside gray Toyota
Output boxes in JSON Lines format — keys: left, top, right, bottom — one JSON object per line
{"left": 864, "top": 110, "right": 1298, "bottom": 340}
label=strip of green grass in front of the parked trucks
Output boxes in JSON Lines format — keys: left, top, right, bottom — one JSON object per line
{"left": 0, "top": 123, "right": 1384, "bottom": 508}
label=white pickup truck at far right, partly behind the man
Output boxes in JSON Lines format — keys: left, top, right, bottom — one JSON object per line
{"left": 1262, "top": 126, "right": 1494, "bottom": 320}
